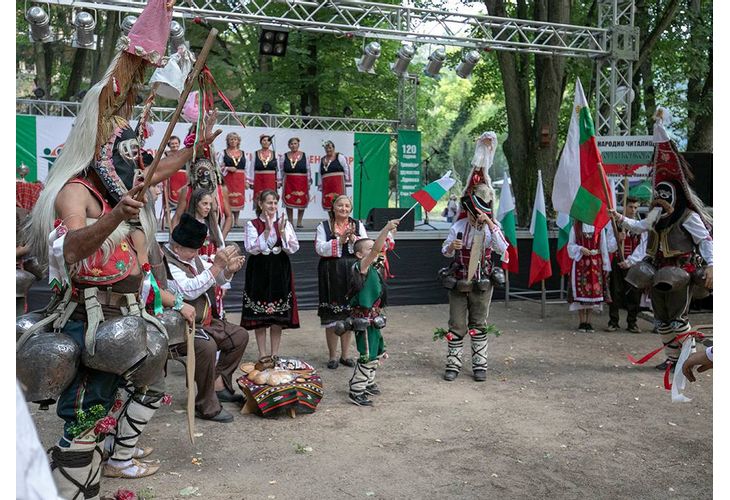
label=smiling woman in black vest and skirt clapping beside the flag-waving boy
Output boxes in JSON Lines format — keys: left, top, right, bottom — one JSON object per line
{"left": 314, "top": 194, "right": 368, "bottom": 370}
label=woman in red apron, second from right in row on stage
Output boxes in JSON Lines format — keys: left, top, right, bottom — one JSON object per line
{"left": 279, "top": 137, "right": 312, "bottom": 228}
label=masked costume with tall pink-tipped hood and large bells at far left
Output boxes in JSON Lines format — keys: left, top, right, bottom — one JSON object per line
{"left": 17, "top": 0, "right": 172, "bottom": 499}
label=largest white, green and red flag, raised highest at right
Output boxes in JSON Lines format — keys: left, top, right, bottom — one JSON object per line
{"left": 553, "top": 79, "right": 611, "bottom": 234}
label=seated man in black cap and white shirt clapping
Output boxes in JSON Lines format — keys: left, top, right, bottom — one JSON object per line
{"left": 162, "top": 214, "right": 248, "bottom": 423}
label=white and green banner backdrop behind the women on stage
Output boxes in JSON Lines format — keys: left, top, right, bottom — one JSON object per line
{"left": 16, "top": 115, "right": 376, "bottom": 220}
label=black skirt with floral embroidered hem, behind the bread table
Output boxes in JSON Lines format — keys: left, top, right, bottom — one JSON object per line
{"left": 241, "top": 251, "right": 299, "bottom": 330}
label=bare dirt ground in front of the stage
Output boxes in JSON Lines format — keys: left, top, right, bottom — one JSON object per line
{"left": 30, "top": 302, "right": 713, "bottom": 500}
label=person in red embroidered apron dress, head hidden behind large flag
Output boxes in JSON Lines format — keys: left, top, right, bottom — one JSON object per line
{"left": 568, "top": 221, "right": 617, "bottom": 332}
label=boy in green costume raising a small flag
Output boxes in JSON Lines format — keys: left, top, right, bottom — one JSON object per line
{"left": 349, "top": 219, "right": 400, "bottom": 406}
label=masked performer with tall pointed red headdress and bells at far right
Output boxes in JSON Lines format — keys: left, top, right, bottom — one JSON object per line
{"left": 621, "top": 108, "right": 713, "bottom": 370}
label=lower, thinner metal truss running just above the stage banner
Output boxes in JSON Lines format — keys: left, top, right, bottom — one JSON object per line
{"left": 15, "top": 99, "right": 399, "bottom": 134}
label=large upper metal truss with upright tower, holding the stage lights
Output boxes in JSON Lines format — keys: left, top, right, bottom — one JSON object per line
{"left": 32, "top": 0, "right": 639, "bottom": 134}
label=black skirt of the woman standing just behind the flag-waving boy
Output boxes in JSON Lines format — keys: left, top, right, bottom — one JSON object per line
{"left": 317, "top": 256, "right": 357, "bottom": 325}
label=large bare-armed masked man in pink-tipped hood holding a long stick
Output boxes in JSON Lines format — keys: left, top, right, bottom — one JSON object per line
{"left": 23, "top": 0, "right": 220, "bottom": 492}
